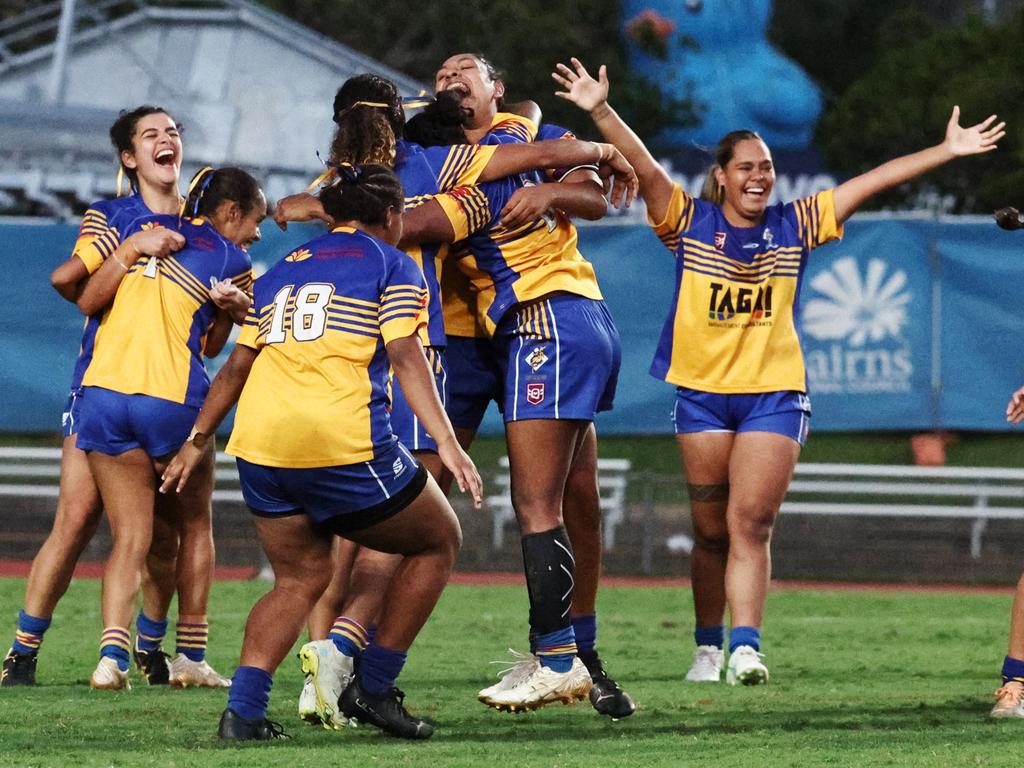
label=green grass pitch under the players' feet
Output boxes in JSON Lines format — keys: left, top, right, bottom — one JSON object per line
{"left": 0, "top": 579, "right": 1024, "bottom": 768}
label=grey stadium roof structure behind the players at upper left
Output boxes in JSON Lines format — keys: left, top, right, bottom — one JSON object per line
{"left": 0, "top": 0, "right": 422, "bottom": 216}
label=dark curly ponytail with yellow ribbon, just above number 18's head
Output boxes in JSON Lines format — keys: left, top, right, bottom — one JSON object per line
{"left": 331, "top": 74, "right": 406, "bottom": 167}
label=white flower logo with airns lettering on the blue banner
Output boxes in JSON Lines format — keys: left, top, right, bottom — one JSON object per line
{"left": 801, "top": 256, "right": 924, "bottom": 394}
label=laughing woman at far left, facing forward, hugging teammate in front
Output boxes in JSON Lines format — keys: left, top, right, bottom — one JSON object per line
{"left": 0, "top": 105, "right": 222, "bottom": 685}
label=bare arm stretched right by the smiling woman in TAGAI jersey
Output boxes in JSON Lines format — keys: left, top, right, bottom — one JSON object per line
{"left": 833, "top": 106, "right": 1007, "bottom": 223}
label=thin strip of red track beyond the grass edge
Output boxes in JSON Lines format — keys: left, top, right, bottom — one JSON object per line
{"left": 0, "top": 560, "right": 1014, "bottom": 595}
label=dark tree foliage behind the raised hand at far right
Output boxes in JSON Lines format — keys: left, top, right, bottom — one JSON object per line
{"left": 817, "top": 11, "right": 1024, "bottom": 213}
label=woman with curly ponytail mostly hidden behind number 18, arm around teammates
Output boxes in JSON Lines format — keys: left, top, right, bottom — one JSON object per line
{"left": 275, "top": 75, "right": 630, "bottom": 726}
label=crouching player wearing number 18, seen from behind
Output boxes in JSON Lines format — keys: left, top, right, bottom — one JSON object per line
{"left": 163, "top": 165, "right": 481, "bottom": 740}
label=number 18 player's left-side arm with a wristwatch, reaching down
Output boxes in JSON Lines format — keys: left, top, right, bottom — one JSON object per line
{"left": 160, "top": 344, "right": 259, "bottom": 494}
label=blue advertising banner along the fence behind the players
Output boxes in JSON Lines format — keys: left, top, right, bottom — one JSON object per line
{"left": 0, "top": 219, "right": 1024, "bottom": 434}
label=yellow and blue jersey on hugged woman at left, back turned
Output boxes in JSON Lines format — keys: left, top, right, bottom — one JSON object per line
{"left": 82, "top": 214, "right": 252, "bottom": 407}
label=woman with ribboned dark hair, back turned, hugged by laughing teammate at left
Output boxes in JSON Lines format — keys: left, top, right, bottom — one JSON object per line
{"left": 78, "top": 168, "right": 266, "bottom": 688}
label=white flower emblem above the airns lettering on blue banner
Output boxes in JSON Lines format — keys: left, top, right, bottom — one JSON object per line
{"left": 802, "top": 257, "right": 911, "bottom": 347}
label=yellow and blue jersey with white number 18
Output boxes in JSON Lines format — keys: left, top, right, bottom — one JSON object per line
{"left": 227, "top": 227, "right": 427, "bottom": 469}
